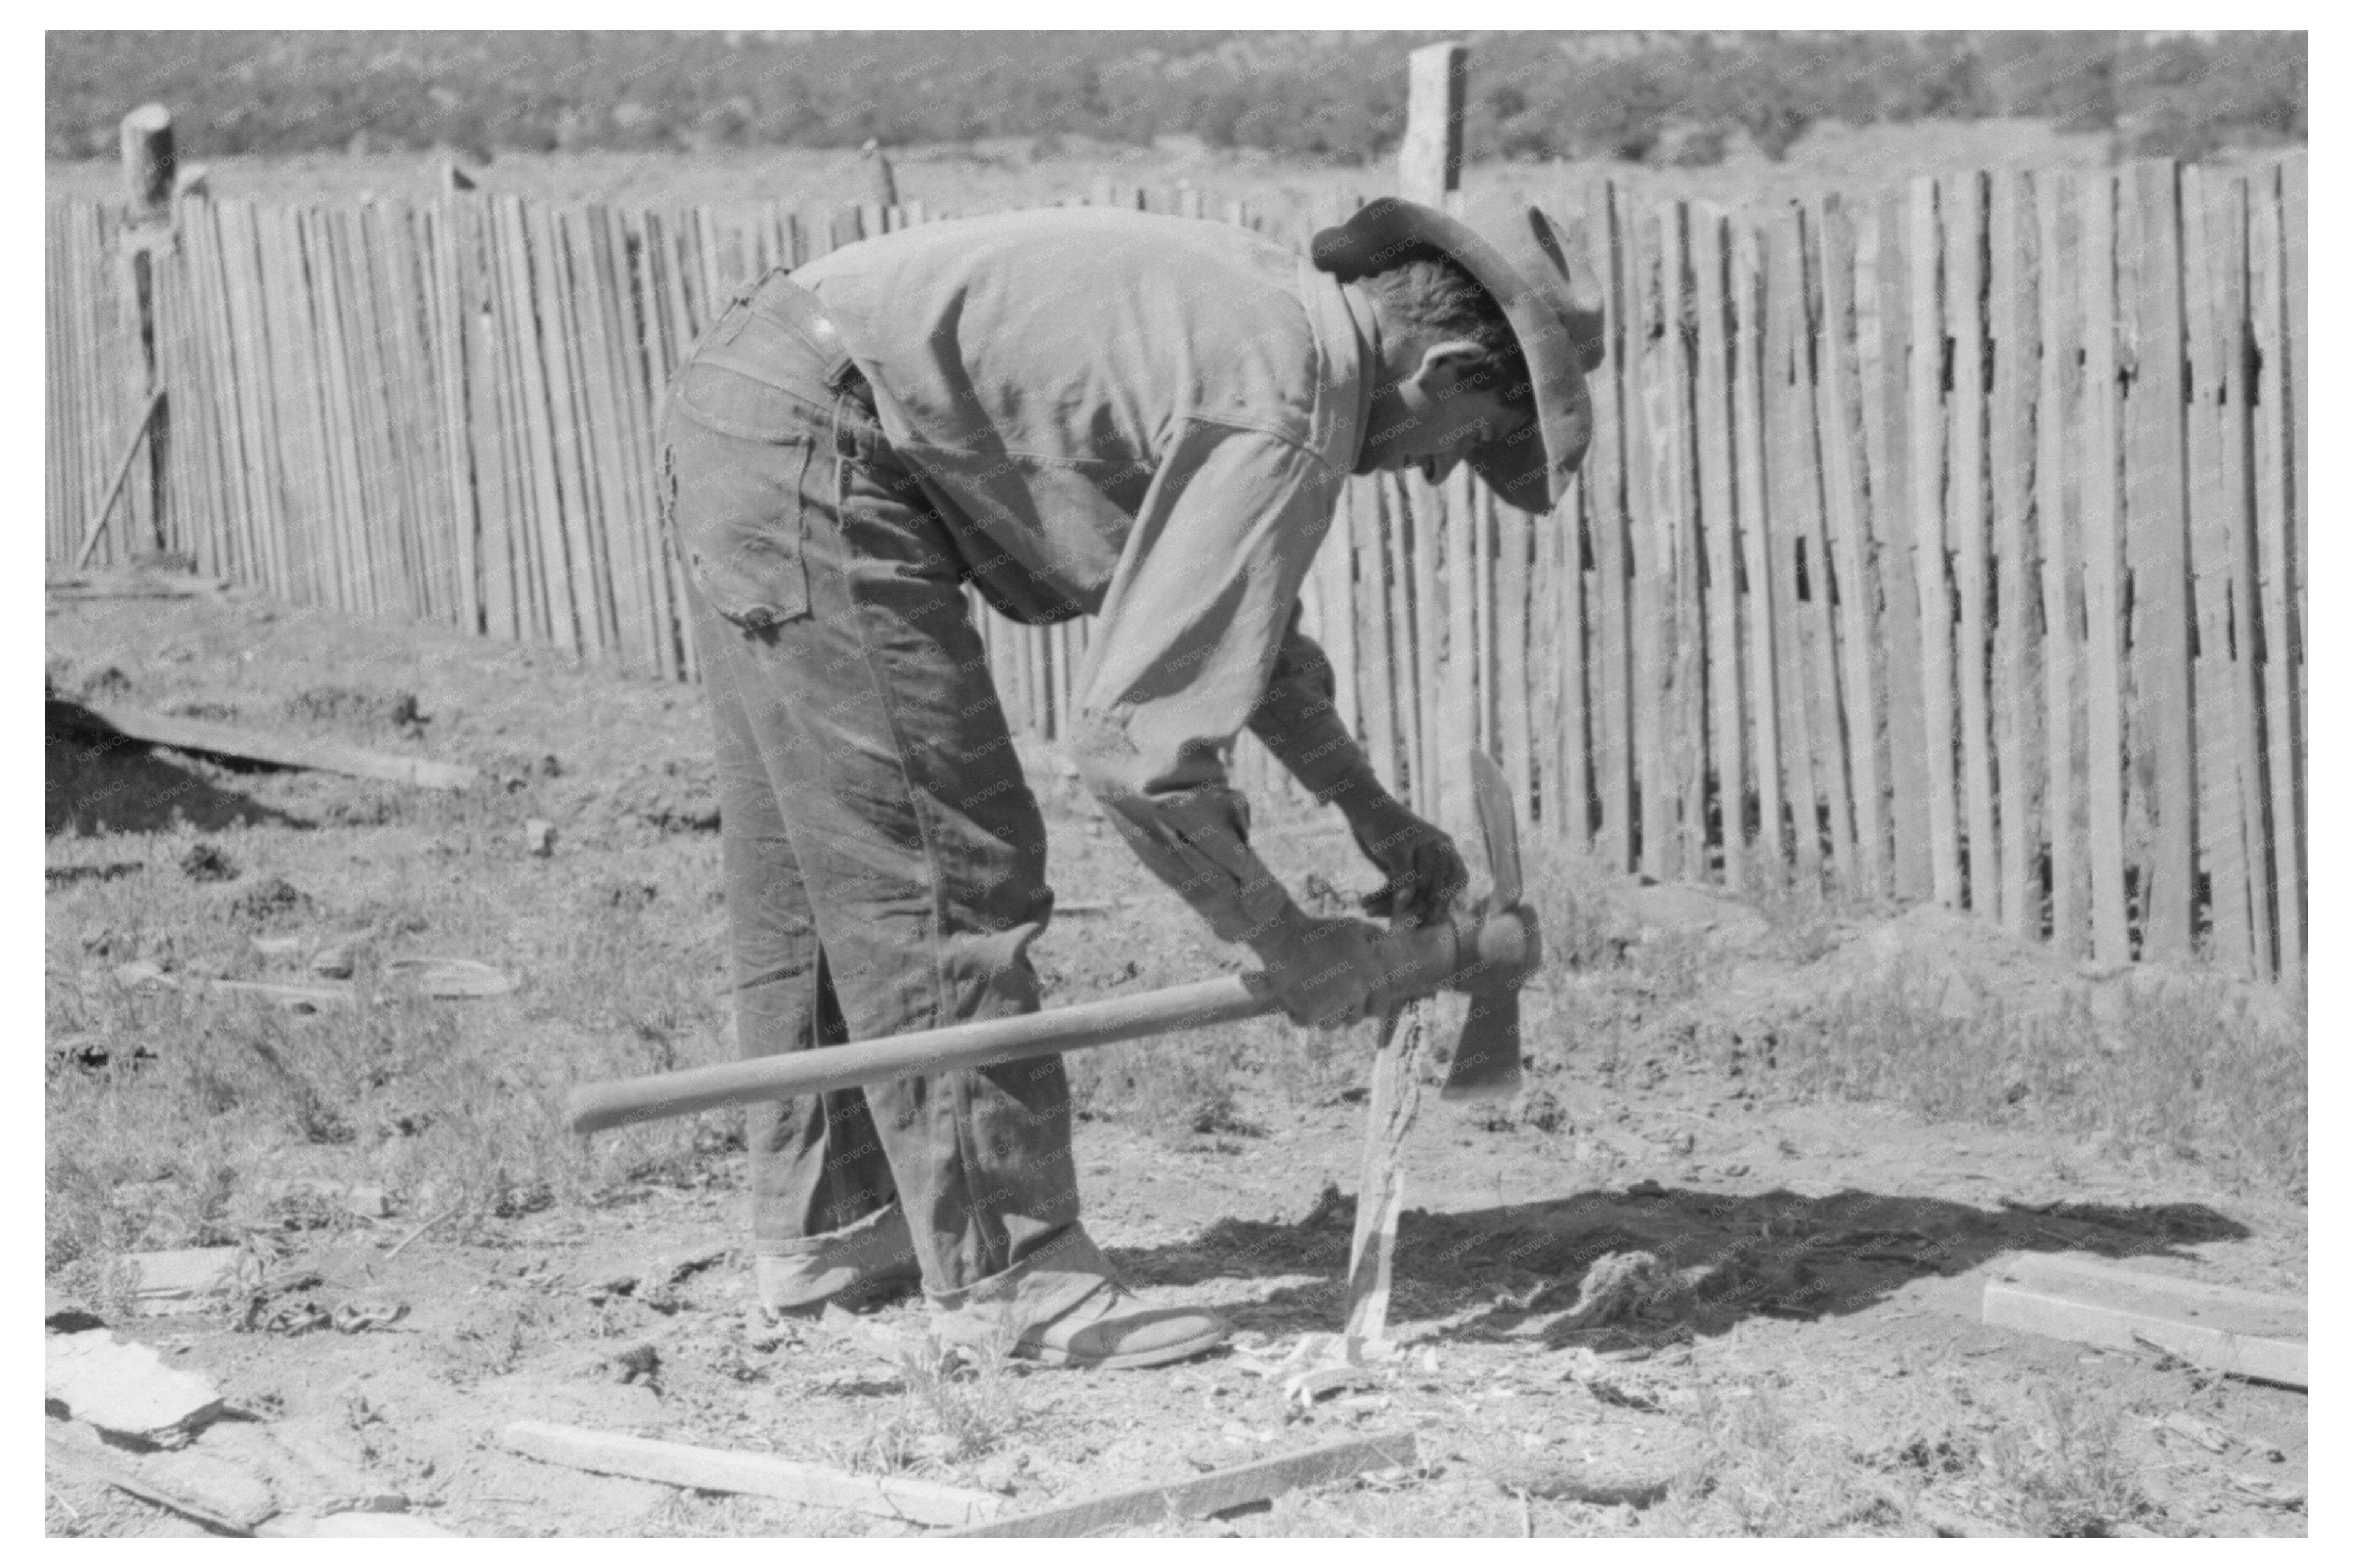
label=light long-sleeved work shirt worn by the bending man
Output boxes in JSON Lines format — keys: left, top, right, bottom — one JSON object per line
{"left": 795, "top": 209, "right": 1379, "bottom": 940}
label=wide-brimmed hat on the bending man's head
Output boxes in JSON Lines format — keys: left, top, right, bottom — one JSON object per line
{"left": 1308, "top": 195, "right": 1603, "bottom": 513}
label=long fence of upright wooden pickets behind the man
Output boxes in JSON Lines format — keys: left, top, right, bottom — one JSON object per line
{"left": 47, "top": 155, "right": 2308, "bottom": 977}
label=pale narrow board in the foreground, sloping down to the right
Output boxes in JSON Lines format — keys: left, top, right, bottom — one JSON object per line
{"left": 501, "top": 1422, "right": 1005, "bottom": 1526}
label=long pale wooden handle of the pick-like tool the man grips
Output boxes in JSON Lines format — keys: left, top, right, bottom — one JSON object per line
{"left": 565, "top": 911, "right": 1534, "bottom": 1132}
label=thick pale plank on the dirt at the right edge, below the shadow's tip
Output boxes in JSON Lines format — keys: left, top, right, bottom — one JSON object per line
{"left": 1984, "top": 1253, "right": 2311, "bottom": 1389}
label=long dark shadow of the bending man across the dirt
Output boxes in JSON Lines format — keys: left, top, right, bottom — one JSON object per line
{"left": 1108, "top": 1186, "right": 2249, "bottom": 1347}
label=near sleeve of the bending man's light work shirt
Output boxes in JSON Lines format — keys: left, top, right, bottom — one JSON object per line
{"left": 1073, "top": 419, "right": 1370, "bottom": 942}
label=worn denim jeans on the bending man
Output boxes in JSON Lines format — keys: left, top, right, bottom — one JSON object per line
{"left": 661, "top": 273, "right": 1101, "bottom": 1307}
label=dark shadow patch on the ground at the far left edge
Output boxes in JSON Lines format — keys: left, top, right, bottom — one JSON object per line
{"left": 42, "top": 697, "right": 311, "bottom": 838}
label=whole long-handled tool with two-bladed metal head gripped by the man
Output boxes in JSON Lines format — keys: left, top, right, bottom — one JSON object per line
{"left": 565, "top": 751, "right": 1544, "bottom": 1132}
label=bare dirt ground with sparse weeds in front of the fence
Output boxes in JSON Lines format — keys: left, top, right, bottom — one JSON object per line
{"left": 45, "top": 576, "right": 2306, "bottom": 1538}
